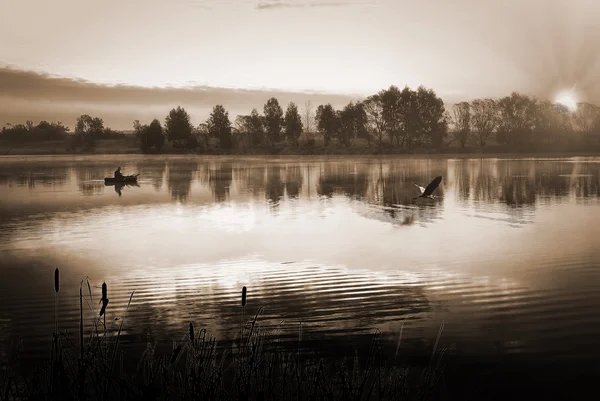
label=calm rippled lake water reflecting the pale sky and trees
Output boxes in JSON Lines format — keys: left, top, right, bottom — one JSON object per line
{"left": 0, "top": 156, "right": 600, "bottom": 372}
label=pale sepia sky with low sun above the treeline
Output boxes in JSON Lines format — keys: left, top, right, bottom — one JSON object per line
{"left": 0, "top": 0, "right": 600, "bottom": 129}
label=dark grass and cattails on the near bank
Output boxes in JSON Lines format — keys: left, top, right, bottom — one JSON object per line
{"left": 0, "top": 269, "right": 450, "bottom": 401}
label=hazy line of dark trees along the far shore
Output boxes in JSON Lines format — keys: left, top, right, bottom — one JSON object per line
{"left": 0, "top": 85, "right": 600, "bottom": 156}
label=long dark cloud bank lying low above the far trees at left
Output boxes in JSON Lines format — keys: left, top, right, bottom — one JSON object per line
{"left": 0, "top": 68, "right": 360, "bottom": 129}
